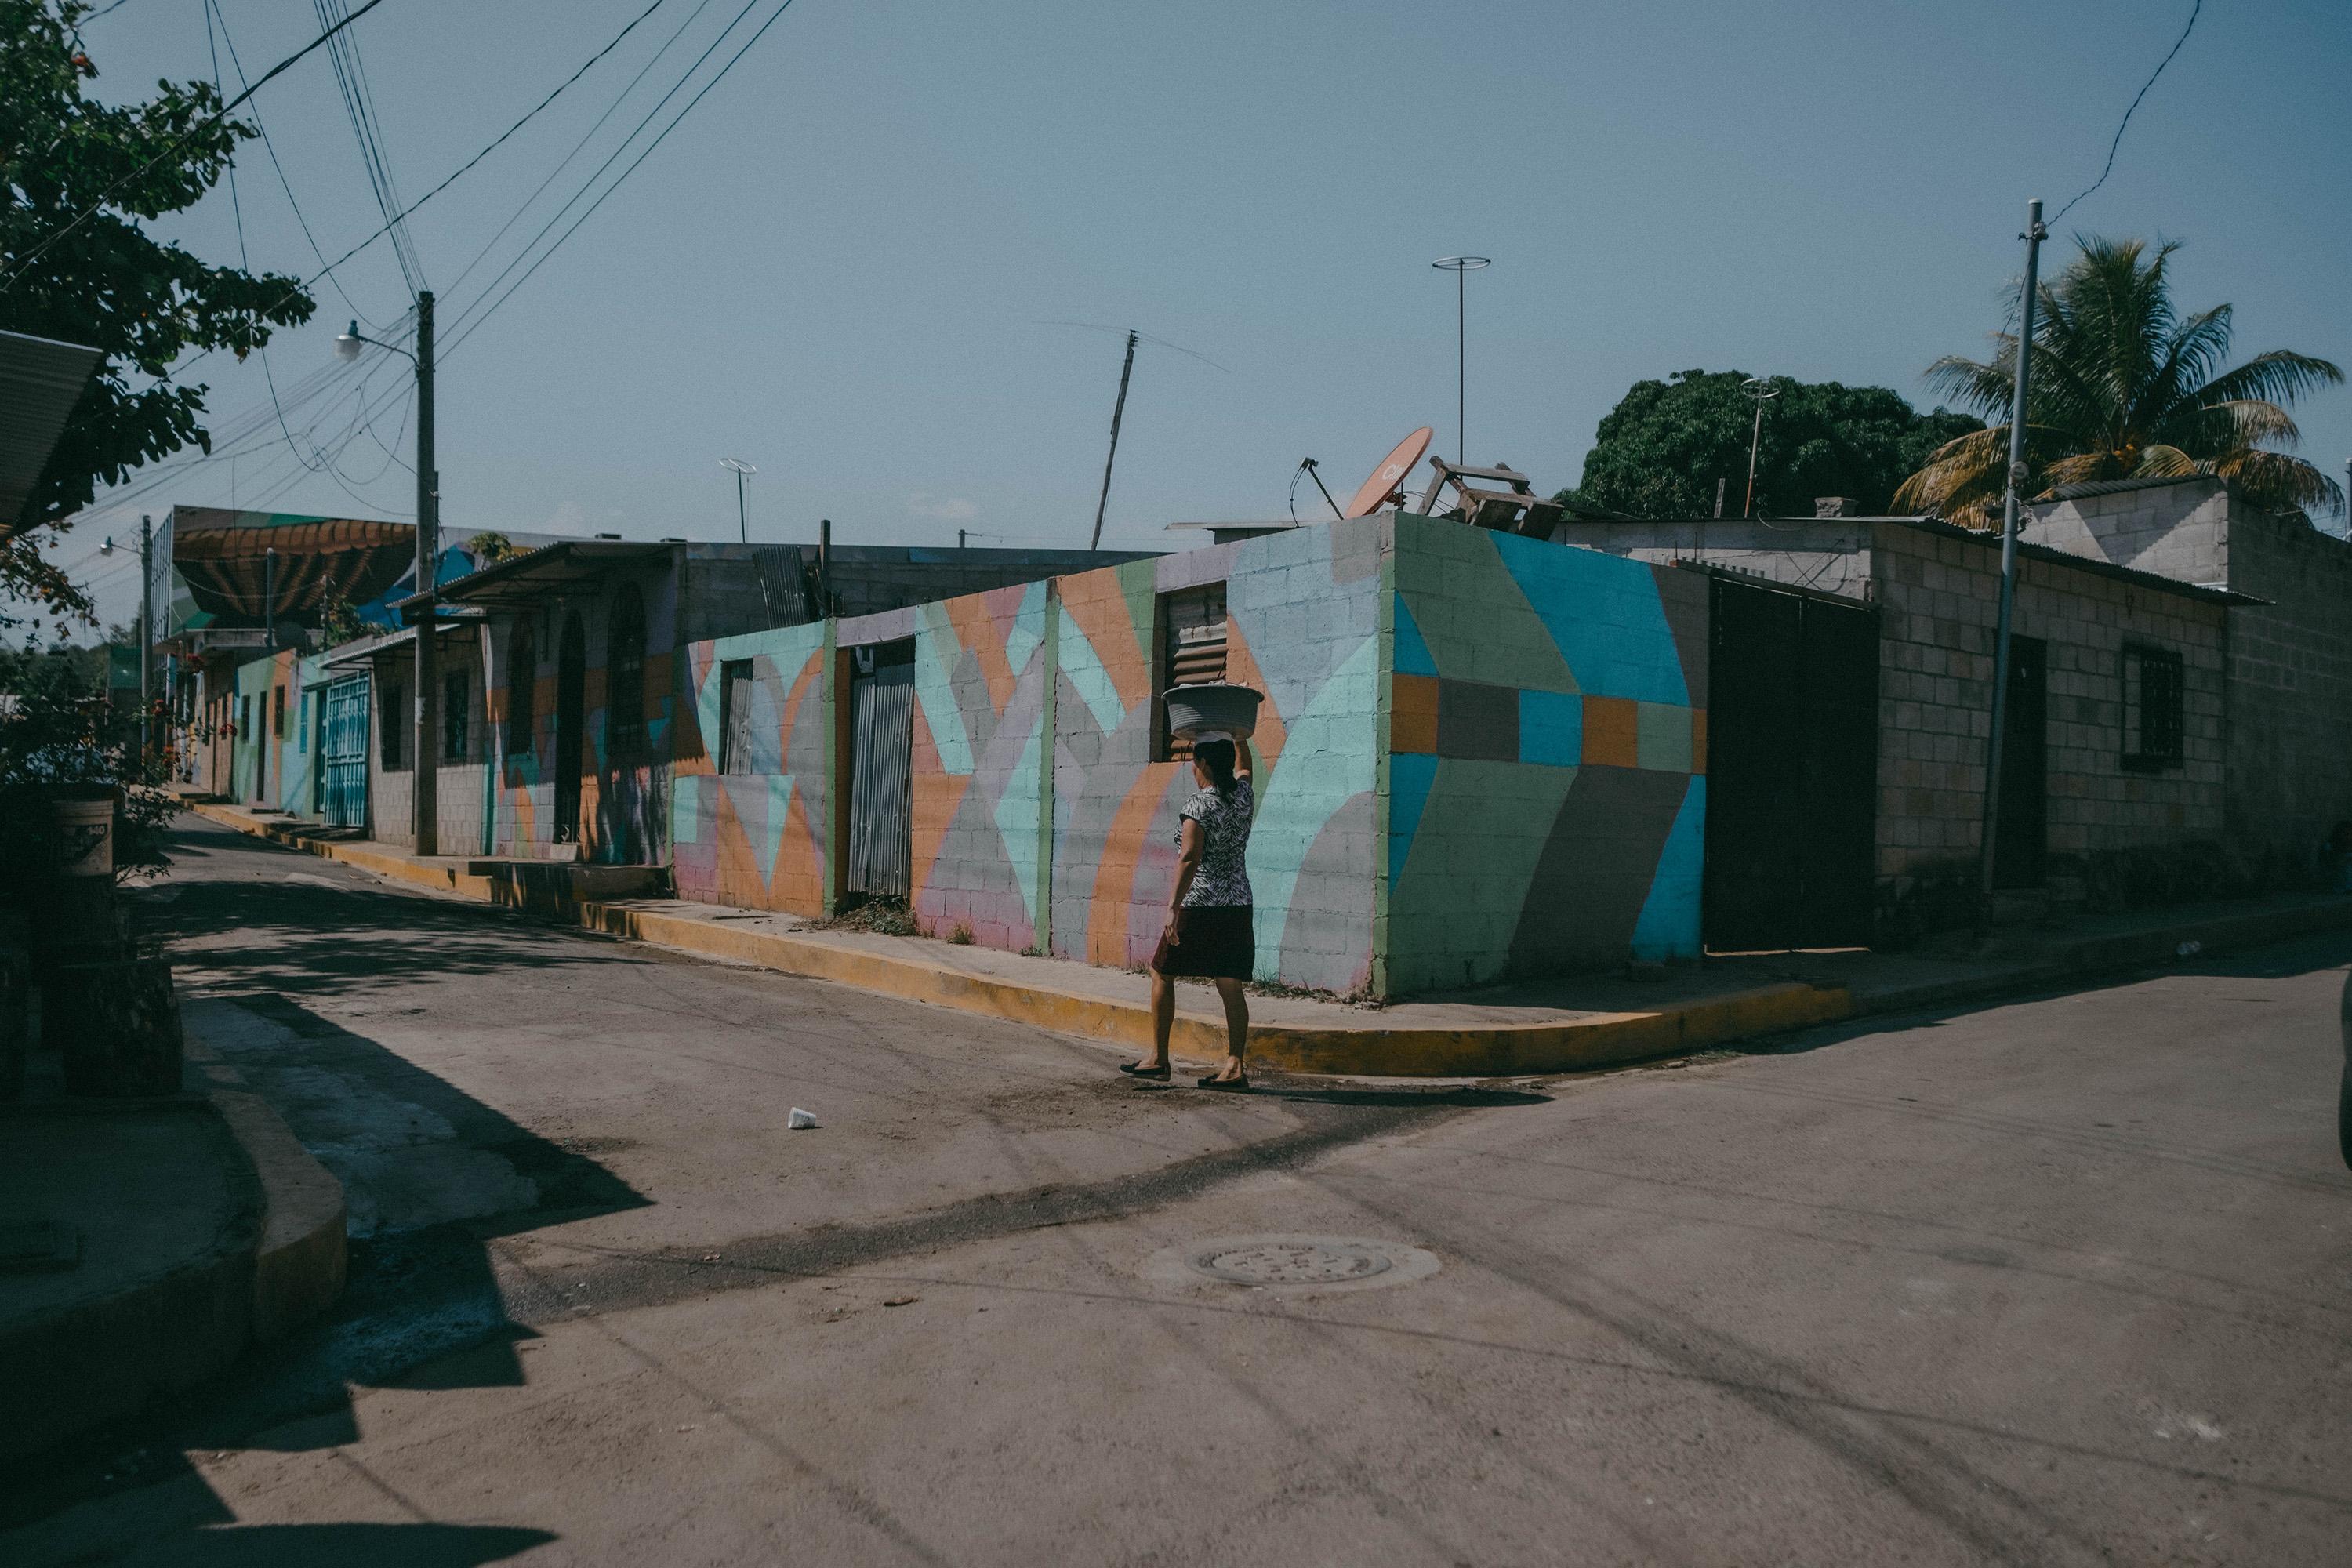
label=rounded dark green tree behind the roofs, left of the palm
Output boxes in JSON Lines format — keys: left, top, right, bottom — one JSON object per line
{"left": 1562, "top": 369, "right": 1980, "bottom": 517}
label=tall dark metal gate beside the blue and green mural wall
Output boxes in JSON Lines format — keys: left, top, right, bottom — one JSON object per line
{"left": 1703, "top": 576, "right": 1879, "bottom": 952}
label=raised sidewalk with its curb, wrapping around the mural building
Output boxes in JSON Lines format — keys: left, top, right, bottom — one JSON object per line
{"left": 191, "top": 801, "right": 2352, "bottom": 1076}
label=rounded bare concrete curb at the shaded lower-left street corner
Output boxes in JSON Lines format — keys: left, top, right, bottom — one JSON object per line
{"left": 0, "top": 1088, "right": 346, "bottom": 1460}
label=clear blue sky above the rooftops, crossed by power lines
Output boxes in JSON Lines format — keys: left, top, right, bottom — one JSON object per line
{"left": 32, "top": 0, "right": 2352, "bottom": 639}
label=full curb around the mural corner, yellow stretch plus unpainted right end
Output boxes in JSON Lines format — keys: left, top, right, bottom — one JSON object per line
{"left": 191, "top": 804, "right": 2352, "bottom": 1076}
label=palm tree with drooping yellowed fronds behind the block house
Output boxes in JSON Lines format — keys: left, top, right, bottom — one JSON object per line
{"left": 1896, "top": 235, "right": 2345, "bottom": 527}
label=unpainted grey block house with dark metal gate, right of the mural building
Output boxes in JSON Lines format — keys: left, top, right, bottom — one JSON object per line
{"left": 1559, "top": 515, "right": 2258, "bottom": 947}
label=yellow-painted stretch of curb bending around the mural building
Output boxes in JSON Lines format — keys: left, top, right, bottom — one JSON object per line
{"left": 191, "top": 804, "right": 1856, "bottom": 1076}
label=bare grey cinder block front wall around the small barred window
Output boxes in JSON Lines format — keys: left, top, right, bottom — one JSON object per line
{"left": 1872, "top": 524, "right": 2227, "bottom": 914}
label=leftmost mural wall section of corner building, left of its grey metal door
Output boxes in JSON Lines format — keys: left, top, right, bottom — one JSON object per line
{"left": 670, "top": 623, "right": 833, "bottom": 914}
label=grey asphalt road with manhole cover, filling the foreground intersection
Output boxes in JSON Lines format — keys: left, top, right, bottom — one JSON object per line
{"left": 0, "top": 825, "right": 2352, "bottom": 1568}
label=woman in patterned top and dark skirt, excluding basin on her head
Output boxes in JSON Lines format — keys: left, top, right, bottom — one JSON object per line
{"left": 1120, "top": 736, "right": 1258, "bottom": 1091}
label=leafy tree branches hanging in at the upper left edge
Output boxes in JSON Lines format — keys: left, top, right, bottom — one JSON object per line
{"left": 0, "top": 0, "right": 310, "bottom": 626}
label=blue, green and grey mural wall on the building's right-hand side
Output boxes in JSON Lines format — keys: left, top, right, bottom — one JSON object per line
{"left": 1381, "top": 517, "right": 1708, "bottom": 992}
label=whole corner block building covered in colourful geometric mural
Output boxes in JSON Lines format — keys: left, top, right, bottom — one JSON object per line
{"left": 670, "top": 515, "right": 1708, "bottom": 994}
